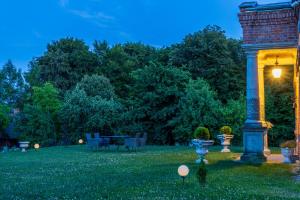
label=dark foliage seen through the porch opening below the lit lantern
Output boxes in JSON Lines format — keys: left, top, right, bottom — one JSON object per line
{"left": 265, "top": 66, "right": 295, "bottom": 146}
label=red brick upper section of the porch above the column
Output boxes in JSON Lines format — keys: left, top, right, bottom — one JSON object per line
{"left": 239, "top": 9, "right": 298, "bottom": 44}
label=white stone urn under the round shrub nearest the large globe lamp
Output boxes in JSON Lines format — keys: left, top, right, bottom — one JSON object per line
{"left": 192, "top": 139, "right": 214, "bottom": 164}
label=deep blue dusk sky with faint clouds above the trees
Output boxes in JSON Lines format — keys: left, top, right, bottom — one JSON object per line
{"left": 0, "top": 0, "right": 279, "bottom": 70}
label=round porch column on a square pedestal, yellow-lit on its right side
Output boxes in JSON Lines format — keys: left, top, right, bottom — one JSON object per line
{"left": 241, "top": 50, "right": 267, "bottom": 162}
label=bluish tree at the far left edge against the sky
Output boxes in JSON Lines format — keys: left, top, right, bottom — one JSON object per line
{"left": 0, "top": 60, "right": 25, "bottom": 107}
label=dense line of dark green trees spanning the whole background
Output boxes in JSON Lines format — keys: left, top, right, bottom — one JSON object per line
{"left": 0, "top": 26, "right": 290, "bottom": 145}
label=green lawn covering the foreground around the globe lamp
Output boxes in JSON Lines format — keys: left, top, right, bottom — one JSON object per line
{"left": 0, "top": 146, "right": 300, "bottom": 200}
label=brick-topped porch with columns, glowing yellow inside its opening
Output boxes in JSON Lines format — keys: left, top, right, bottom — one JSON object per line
{"left": 239, "top": 0, "right": 300, "bottom": 162}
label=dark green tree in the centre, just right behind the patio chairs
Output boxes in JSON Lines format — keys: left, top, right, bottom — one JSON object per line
{"left": 126, "top": 63, "right": 190, "bottom": 144}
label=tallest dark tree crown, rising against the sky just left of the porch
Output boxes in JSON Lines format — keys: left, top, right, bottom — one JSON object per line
{"left": 170, "top": 26, "right": 245, "bottom": 103}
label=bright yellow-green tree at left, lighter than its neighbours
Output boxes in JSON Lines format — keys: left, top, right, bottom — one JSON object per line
{"left": 16, "top": 83, "right": 61, "bottom": 146}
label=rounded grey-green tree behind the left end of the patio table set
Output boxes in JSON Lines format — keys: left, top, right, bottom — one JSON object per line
{"left": 60, "top": 75, "right": 123, "bottom": 142}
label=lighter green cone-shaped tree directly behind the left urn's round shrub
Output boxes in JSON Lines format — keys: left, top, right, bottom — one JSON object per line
{"left": 172, "top": 79, "right": 222, "bottom": 143}
